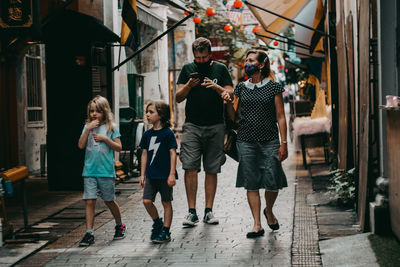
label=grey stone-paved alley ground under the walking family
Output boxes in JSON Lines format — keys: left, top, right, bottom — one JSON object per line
{"left": 30, "top": 144, "right": 296, "bottom": 267}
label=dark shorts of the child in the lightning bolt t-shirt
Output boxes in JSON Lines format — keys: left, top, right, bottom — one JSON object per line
{"left": 143, "top": 178, "right": 173, "bottom": 202}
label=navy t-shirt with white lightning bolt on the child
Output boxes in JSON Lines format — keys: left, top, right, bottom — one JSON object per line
{"left": 139, "top": 128, "right": 178, "bottom": 179}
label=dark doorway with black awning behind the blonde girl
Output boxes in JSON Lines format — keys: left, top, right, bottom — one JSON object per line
{"left": 43, "top": 10, "right": 119, "bottom": 190}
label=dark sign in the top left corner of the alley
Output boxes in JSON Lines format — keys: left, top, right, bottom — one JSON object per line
{"left": 0, "top": 0, "right": 33, "bottom": 28}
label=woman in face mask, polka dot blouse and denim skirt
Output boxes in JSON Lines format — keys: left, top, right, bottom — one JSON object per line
{"left": 224, "top": 50, "right": 288, "bottom": 238}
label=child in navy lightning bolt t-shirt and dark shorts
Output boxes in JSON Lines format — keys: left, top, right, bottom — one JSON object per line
{"left": 139, "top": 101, "right": 177, "bottom": 243}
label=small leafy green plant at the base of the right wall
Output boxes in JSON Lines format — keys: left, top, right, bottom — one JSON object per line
{"left": 328, "top": 168, "right": 356, "bottom": 206}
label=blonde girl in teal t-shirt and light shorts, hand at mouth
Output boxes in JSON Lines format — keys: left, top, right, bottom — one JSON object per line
{"left": 78, "top": 96, "right": 126, "bottom": 246}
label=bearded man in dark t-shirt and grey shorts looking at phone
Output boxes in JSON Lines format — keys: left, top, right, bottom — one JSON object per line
{"left": 176, "top": 37, "right": 233, "bottom": 226}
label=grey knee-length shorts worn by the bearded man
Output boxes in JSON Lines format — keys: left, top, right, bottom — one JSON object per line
{"left": 179, "top": 122, "right": 226, "bottom": 174}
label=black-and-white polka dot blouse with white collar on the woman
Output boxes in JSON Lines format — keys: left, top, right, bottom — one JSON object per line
{"left": 233, "top": 79, "right": 284, "bottom": 142}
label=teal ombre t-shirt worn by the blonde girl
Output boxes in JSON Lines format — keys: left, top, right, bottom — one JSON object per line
{"left": 82, "top": 124, "right": 121, "bottom": 177}
